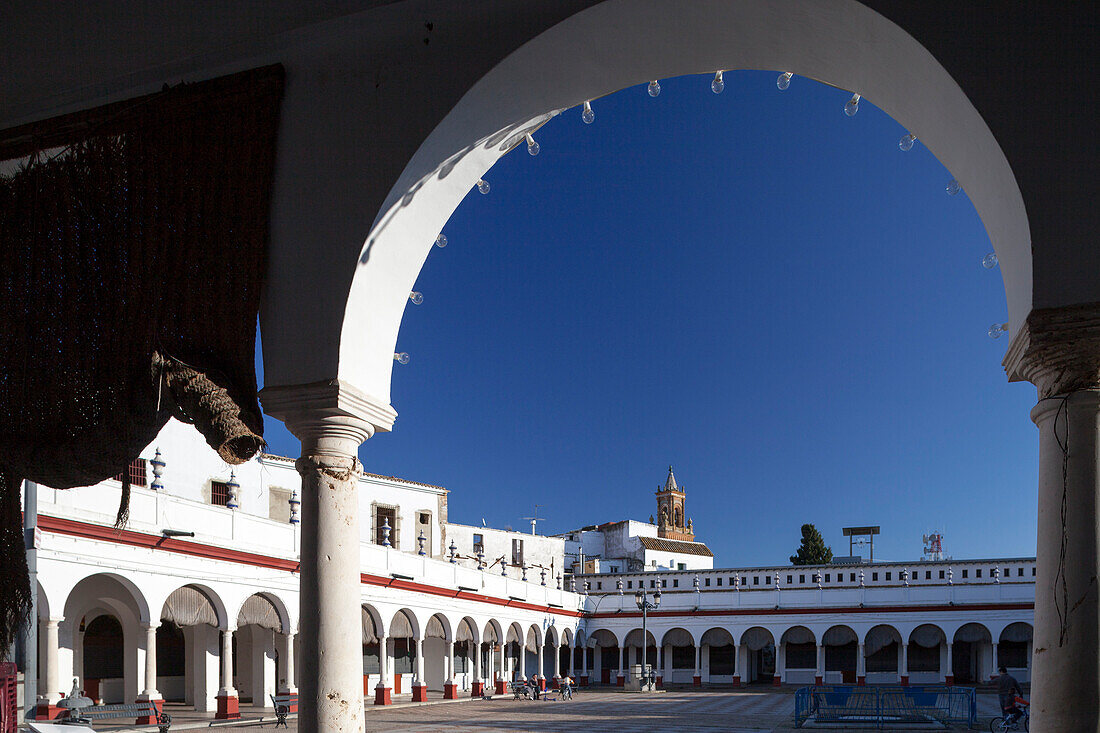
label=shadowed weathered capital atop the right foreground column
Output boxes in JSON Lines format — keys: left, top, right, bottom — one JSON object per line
{"left": 1001, "top": 303, "right": 1100, "bottom": 400}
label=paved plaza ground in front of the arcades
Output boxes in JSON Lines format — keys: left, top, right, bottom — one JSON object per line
{"left": 83, "top": 689, "right": 1012, "bottom": 733}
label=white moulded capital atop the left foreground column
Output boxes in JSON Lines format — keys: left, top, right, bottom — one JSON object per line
{"left": 260, "top": 380, "right": 397, "bottom": 456}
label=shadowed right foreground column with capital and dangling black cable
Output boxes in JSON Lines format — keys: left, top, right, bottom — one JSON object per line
{"left": 1003, "top": 303, "right": 1100, "bottom": 731}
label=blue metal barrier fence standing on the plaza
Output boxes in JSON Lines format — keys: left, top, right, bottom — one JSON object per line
{"left": 794, "top": 685, "right": 978, "bottom": 730}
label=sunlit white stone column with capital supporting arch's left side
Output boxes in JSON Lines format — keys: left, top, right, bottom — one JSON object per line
{"left": 261, "top": 380, "right": 397, "bottom": 733}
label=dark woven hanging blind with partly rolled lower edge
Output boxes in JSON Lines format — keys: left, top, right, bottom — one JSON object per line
{"left": 0, "top": 66, "right": 283, "bottom": 648}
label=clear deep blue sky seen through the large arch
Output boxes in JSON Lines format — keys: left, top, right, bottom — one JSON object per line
{"left": 257, "top": 72, "right": 1037, "bottom": 566}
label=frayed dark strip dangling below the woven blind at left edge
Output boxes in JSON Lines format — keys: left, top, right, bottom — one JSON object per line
{"left": 0, "top": 469, "right": 31, "bottom": 655}
